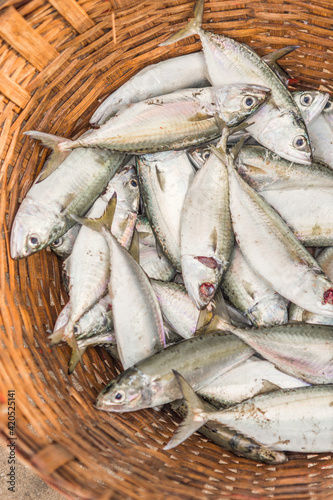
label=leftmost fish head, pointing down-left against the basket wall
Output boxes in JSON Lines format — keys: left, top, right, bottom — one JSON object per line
{"left": 10, "top": 200, "right": 64, "bottom": 259}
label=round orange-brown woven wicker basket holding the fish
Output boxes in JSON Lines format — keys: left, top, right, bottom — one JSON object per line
{"left": 0, "top": 0, "right": 333, "bottom": 500}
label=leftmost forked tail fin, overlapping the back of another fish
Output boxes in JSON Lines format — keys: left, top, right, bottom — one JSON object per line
{"left": 24, "top": 130, "right": 72, "bottom": 182}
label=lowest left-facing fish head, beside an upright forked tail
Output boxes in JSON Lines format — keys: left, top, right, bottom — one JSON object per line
{"left": 95, "top": 366, "right": 152, "bottom": 412}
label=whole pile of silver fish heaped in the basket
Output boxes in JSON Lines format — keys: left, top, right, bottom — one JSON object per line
{"left": 11, "top": 0, "right": 333, "bottom": 463}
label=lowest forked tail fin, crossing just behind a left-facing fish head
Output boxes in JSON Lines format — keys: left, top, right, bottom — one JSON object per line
{"left": 164, "top": 370, "right": 209, "bottom": 450}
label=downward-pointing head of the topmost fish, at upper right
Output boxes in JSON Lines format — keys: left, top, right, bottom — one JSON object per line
{"left": 247, "top": 104, "right": 312, "bottom": 165}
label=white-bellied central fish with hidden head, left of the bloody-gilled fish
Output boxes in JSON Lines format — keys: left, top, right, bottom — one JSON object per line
{"left": 136, "top": 151, "right": 194, "bottom": 271}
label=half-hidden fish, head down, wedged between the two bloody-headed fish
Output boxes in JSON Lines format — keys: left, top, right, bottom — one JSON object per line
{"left": 221, "top": 244, "right": 288, "bottom": 326}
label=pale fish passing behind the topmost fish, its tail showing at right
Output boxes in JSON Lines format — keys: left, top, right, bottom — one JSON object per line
{"left": 90, "top": 45, "right": 298, "bottom": 127}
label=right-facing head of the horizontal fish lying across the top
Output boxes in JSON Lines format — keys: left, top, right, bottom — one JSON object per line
{"left": 215, "top": 84, "right": 271, "bottom": 127}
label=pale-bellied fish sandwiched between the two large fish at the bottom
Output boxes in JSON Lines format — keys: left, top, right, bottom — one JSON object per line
{"left": 198, "top": 356, "right": 308, "bottom": 408}
